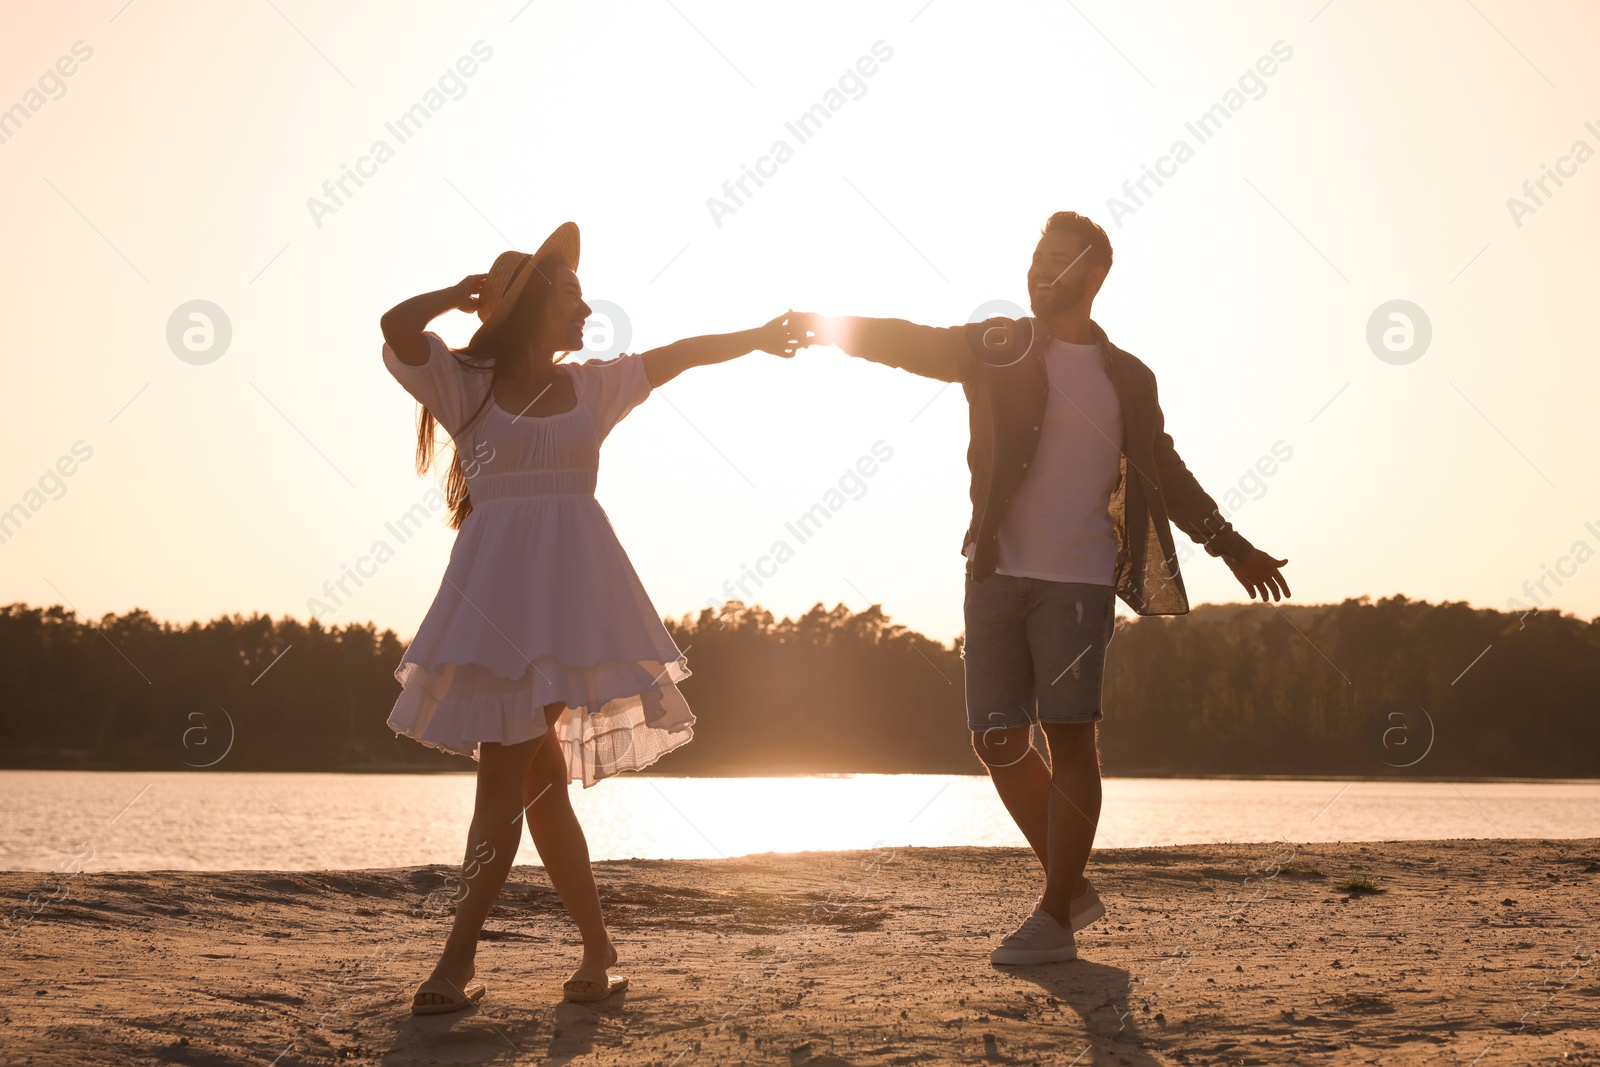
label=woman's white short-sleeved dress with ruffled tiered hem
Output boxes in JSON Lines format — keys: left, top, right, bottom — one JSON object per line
{"left": 384, "top": 333, "right": 694, "bottom": 787}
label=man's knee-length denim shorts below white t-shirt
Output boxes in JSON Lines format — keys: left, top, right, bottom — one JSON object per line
{"left": 962, "top": 574, "right": 1117, "bottom": 733}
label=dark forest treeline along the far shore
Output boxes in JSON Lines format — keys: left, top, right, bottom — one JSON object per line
{"left": 0, "top": 597, "right": 1600, "bottom": 777}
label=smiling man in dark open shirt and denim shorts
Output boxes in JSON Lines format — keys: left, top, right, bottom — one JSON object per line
{"left": 795, "top": 211, "right": 1290, "bottom": 965}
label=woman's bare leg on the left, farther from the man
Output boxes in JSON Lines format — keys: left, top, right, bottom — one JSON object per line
{"left": 414, "top": 737, "right": 546, "bottom": 1005}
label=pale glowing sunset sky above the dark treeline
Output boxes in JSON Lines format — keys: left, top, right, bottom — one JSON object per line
{"left": 0, "top": 0, "right": 1600, "bottom": 640}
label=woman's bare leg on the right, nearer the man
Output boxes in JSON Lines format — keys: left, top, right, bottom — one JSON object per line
{"left": 522, "top": 704, "right": 616, "bottom": 990}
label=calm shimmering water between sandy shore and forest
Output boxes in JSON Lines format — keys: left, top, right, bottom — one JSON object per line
{"left": 0, "top": 771, "right": 1600, "bottom": 870}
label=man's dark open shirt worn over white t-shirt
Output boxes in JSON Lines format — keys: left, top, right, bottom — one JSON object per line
{"left": 837, "top": 318, "right": 1253, "bottom": 614}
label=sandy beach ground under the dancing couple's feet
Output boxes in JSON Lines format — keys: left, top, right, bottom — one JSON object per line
{"left": 0, "top": 840, "right": 1600, "bottom": 1067}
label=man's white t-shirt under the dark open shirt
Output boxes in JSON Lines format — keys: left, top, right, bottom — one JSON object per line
{"left": 995, "top": 341, "right": 1122, "bottom": 585}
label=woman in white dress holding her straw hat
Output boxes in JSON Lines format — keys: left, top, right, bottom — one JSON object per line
{"left": 382, "top": 222, "right": 795, "bottom": 1014}
